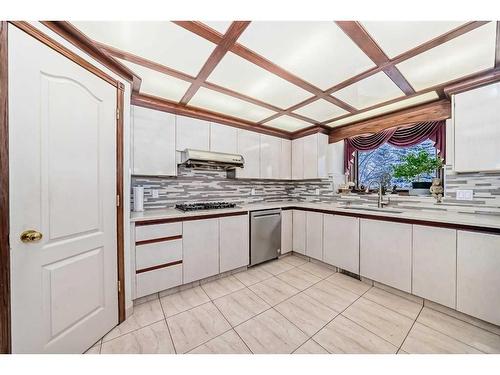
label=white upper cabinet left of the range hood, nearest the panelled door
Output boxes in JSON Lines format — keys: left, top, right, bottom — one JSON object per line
{"left": 132, "top": 106, "right": 177, "bottom": 176}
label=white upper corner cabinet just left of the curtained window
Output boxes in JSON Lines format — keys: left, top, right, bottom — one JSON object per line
{"left": 292, "top": 133, "right": 328, "bottom": 180}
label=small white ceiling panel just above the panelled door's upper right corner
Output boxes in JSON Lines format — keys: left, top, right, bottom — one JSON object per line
{"left": 118, "top": 59, "right": 190, "bottom": 101}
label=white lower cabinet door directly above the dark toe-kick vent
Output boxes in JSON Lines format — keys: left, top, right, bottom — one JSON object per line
{"left": 323, "top": 214, "right": 359, "bottom": 274}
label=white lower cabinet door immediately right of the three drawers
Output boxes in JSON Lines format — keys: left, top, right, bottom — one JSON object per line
{"left": 182, "top": 219, "right": 219, "bottom": 284}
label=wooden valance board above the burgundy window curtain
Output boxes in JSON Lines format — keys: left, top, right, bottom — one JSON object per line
{"left": 329, "top": 100, "right": 451, "bottom": 143}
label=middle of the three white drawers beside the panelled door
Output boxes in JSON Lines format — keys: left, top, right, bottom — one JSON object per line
{"left": 135, "top": 239, "right": 182, "bottom": 270}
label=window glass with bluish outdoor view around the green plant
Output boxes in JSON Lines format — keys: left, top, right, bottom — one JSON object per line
{"left": 356, "top": 139, "right": 436, "bottom": 189}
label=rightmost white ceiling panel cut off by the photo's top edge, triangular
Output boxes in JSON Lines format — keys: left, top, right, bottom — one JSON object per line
{"left": 361, "top": 21, "right": 464, "bottom": 58}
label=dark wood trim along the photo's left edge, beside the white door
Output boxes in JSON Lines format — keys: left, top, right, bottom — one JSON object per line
{"left": 0, "top": 21, "right": 12, "bottom": 354}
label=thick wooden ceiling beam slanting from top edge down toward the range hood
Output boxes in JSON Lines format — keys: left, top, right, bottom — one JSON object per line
{"left": 180, "top": 21, "right": 250, "bottom": 105}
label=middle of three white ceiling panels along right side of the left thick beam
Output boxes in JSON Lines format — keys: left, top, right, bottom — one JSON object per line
{"left": 208, "top": 52, "right": 312, "bottom": 108}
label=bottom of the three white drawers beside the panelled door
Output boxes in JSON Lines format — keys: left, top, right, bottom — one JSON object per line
{"left": 135, "top": 264, "right": 182, "bottom": 298}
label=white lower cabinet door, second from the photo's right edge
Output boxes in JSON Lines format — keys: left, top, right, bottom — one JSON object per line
{"left": 412, "top": 225, "right": 457, "bottom": 309}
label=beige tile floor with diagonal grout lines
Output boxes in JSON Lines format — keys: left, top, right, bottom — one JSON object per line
{"left": 87, "top": 256, "right": 500, "bottom": 354}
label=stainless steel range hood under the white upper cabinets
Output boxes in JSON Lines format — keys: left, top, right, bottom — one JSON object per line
{"left": 181, "top": 148, "right": 245, "bottom": 170}
